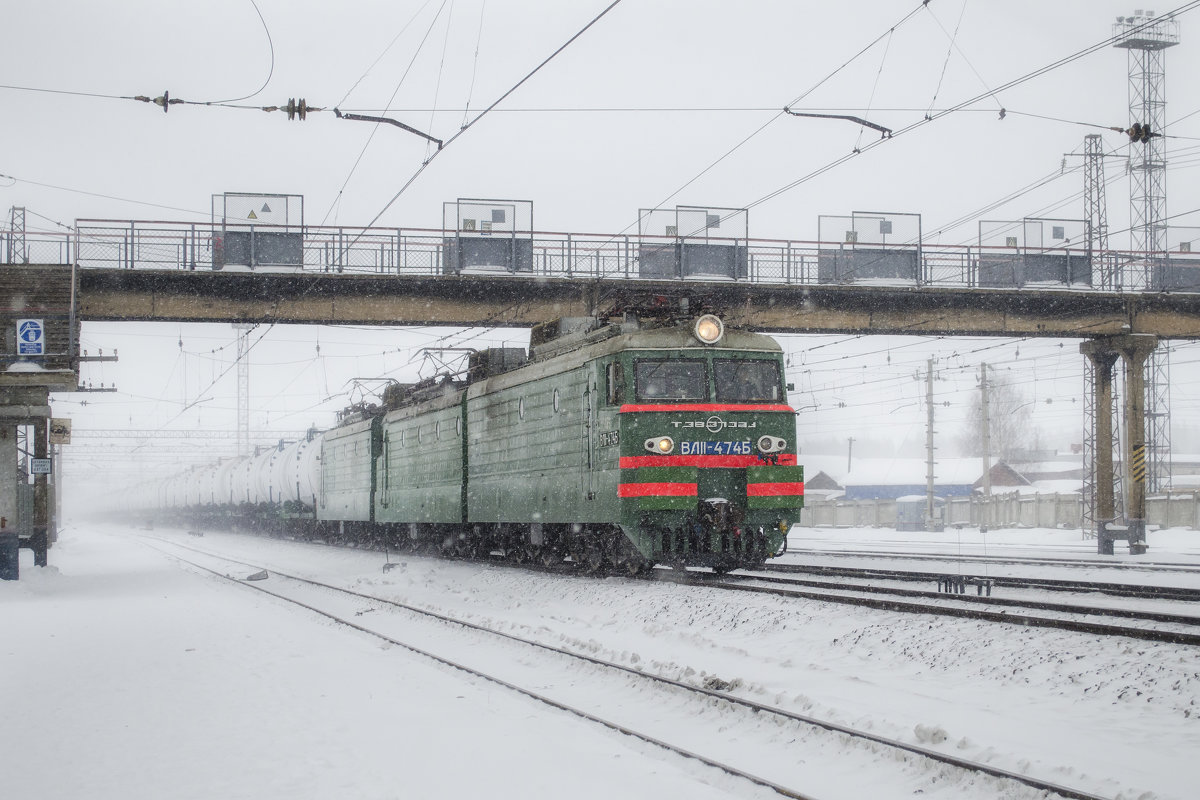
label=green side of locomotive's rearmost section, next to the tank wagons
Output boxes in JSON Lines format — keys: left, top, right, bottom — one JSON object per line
{"left": 317, "top": 416, "right": 382, "bottom": 522}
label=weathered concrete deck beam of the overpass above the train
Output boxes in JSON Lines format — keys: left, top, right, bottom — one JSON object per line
{"left": 78, "top": 270, "right": 1200, "bottom": 339}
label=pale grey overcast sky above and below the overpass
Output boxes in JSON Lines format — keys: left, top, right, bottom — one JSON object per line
{"left": 7, "top": 0, "right": 1200, "bottom": 489}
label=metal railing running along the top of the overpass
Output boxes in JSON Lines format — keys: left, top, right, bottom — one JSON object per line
{"left": 0, "top": 219, "right": 1200, "bottom": 291}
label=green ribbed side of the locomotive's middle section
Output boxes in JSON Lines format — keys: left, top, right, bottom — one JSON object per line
{"left": 374, "top": 387, "right": 466, "bottom": 524}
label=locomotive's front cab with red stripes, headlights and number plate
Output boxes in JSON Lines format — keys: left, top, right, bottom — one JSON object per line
{"left": 607, "top": 317, "right": 804, "bottom": 571}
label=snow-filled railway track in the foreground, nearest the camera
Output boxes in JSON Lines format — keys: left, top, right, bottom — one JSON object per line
{"left": 140, "top": 536, "right": 1102, "bottom": 800}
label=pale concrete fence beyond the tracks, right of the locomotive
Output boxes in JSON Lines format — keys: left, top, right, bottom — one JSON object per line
{"left": 799, "top": 489, "right": 1200, "bottom": 529}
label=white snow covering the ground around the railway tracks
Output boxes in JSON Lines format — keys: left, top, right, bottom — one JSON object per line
{"left": 0, "top": 524, "right": 1200, "bottom": 800}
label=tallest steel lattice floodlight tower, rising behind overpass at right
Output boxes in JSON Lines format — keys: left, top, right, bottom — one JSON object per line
{"left": 1112, "top": 10, "right": 1180, "bottom": 492}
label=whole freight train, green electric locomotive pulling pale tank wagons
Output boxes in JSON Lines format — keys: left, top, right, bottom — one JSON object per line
{"left": 155, "top": 313, "right": 804, "bottom": 575}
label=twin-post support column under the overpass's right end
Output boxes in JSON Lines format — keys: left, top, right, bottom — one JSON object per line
{"left": 1079, "top": 333, "right": 1158, "bottom": 555}
